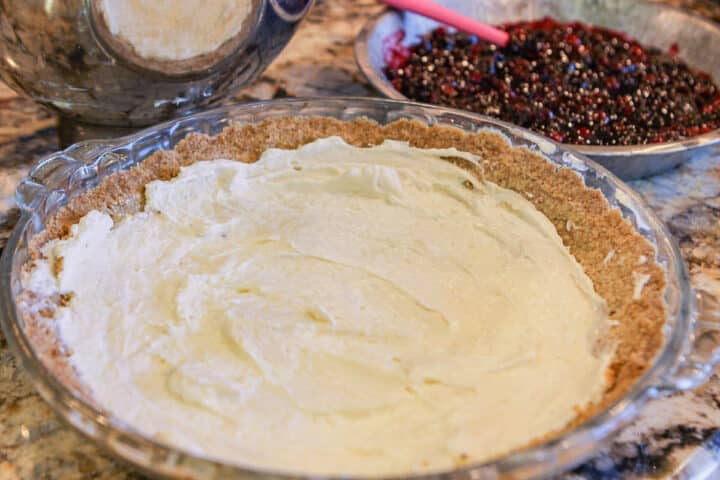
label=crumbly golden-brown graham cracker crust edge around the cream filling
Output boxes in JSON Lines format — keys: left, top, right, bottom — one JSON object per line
{"left": 18, "top": 118, "right": 666, "bottom": 460}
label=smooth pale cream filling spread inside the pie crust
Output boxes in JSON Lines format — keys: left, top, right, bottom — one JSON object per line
{"left": 26, "top": 138, "right": 611, "bottom": 475}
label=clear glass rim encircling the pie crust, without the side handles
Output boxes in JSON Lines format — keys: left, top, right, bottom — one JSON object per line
{"left": 0, "top": 97, "right": 696, "bottom": 480}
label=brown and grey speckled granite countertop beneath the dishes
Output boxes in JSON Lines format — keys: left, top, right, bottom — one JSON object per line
{"left": 0, "top": 0, "right": 720, "bottom": 479}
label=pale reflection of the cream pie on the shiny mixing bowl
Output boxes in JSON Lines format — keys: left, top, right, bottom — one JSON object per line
{"left": 98, "top": 0, "right": 252, "bottom": 61}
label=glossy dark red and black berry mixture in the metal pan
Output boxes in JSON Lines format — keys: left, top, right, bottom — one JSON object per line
{"left": 385, "top": 18, "right": 720, "bottom": 145}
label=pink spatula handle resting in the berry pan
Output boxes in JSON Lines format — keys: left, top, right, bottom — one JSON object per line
{"left": 381, "top": 0, "right": 510, "bottom": 47}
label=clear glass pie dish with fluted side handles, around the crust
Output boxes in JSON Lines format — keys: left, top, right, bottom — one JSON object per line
{"left": 0, "top": 98, "right": 720, "bottom": 479}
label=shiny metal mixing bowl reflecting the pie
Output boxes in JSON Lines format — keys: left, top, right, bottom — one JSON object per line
{"left": 0, "top": 0, "right": 313, "bottom": 143}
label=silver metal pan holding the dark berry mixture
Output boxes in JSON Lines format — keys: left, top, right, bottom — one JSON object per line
{"left": 355, "top": 0, "right": 720, "bottom": 180}
